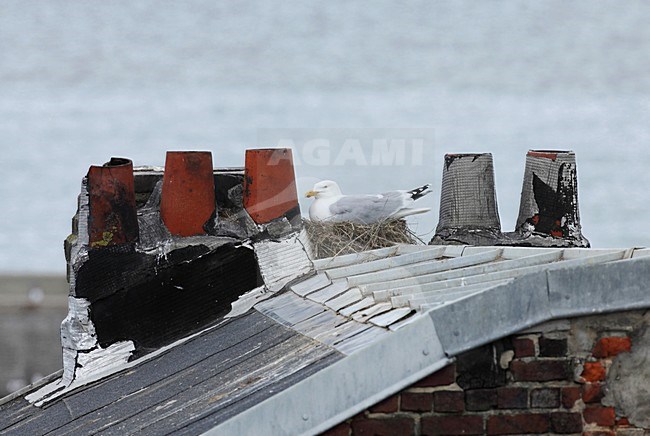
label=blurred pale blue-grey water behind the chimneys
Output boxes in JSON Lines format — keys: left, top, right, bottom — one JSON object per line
{"left": 0, "top": 0, "right": 650, "bottom": 274}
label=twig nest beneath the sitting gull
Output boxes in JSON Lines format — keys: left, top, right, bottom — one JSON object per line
{"left": 304, "top": 220, "right": 422, "bottom": 259}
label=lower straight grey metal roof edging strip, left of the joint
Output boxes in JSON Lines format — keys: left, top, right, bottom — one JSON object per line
{"left": 204, "top": 317, "right": 453, "bottom": 435}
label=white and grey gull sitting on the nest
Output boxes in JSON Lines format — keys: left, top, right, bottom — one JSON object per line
{"left": 306, "top": 180, "right": 431, "bottom": 224}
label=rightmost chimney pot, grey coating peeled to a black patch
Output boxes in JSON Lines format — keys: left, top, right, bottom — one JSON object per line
{"left": 515, "top": 150, "right": 589, "bottom": 247}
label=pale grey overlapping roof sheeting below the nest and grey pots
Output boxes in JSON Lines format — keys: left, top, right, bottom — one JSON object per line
{"left": 290, "top": 246, "right": 633, "bottom": 327}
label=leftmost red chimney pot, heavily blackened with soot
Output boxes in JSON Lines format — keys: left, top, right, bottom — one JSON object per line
{"left": 87, "top": 157, "right": 139, "bottom": 248}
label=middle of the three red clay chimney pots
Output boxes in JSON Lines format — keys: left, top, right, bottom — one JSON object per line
{"left": 160, "top": 151, "right": 216, "bottom": 236}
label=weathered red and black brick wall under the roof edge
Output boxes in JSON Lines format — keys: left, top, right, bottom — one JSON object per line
{"left": 326, "top": 313, "right": 650, "bottom": 436}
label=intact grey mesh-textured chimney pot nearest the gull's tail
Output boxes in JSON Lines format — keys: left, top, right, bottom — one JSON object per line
{"left": 430, "top": 153, "right": 502, "bottom": 245}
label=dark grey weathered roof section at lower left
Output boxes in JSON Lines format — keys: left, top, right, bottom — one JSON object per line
{"left": 0, "top": 311, "right": 341, "bottom": 435}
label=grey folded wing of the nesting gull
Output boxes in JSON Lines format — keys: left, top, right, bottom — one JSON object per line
{"left": 330, "top": 191, "right": 404, "bottom": 224}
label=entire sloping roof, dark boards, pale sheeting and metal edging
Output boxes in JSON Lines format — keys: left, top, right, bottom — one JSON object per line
{"left": 0, "top": 235, "right": 650, "bottom": 434}
